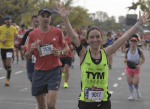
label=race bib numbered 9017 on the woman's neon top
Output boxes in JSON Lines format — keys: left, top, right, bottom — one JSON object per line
{"left": 84, "top": 85, "right": 104, "bottom": 102}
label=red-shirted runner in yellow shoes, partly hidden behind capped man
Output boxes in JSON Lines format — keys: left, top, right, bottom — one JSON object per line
{"left": 60, "top": 26, "right": 72, "bottom": 88}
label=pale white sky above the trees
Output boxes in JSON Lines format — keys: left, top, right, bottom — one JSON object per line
{"left": 61, "top": 0, "right": 140, "bottom": 22}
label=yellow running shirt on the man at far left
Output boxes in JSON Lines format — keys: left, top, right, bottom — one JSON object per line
{"left": 0, "top": 25, "right": 18, "bottom": 49}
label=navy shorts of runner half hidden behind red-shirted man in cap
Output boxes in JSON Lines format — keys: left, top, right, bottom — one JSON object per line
{"left": 26, "top": 59, "right": 34, "bottom": 81}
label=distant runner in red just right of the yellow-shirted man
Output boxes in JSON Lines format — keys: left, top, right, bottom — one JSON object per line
{"left": 14, "top": 24, "right": 26, "bottom": 67}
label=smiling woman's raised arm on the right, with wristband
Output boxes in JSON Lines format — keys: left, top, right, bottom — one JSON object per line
{"left": 105, "top": 10, "right": 150, "bottom": 56}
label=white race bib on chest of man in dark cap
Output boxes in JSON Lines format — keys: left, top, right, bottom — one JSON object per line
{"left": 38, "top": 44, "right": 53, "bottom": 57}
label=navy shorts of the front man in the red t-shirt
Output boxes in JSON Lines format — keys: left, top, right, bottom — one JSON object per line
{"left": 32, "top": 67, "right": 62, "bottom": 96}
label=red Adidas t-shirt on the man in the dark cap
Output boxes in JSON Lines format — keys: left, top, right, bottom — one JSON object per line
{"left": 24, "top": 26, "right": 65, "bottom": 70}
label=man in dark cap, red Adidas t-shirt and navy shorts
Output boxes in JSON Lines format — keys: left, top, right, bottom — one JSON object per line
{"left": 24, "top": 8, "right": 69, "bottom": 109}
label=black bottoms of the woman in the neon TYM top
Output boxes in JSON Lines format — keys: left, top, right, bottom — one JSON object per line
{"left": 78, "top": 100, "right": 111, "bottom": 109}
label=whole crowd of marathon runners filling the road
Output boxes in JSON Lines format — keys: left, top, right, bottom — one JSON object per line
{"left": 0, "top": 3, "right": 150, "bottom": 109}
